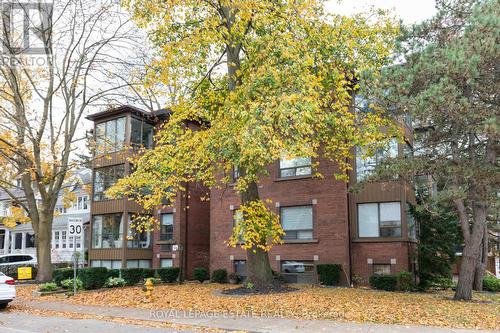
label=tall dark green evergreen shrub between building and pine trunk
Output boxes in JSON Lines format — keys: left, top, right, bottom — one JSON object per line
{"left": 411, "top": 195, "right": 461, "bottom": 290}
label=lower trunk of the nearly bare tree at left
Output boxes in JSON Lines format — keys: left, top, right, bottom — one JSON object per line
{"left": 35, "top": 219, "right": 52, "bottom": 282}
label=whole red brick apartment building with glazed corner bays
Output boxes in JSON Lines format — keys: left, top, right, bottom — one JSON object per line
{"left": 89, "top": 106, "right": 417, "bottom": 284}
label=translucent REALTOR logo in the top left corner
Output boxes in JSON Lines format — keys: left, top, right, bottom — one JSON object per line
{"left": 0, "top": 0, "right": 53, "bottom": 56}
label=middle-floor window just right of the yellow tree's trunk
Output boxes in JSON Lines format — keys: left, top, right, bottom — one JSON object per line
{"left": 280, "top": 206, "right": 313, "bottom": 239}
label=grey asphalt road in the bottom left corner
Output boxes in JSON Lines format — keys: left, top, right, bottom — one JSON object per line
{"left": 0, "top": 311, "right": 198, "bottom": 333}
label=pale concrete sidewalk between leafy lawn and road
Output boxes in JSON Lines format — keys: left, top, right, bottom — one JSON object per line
{"left": 16, "top": 300, "right": 500, "bottom": 333}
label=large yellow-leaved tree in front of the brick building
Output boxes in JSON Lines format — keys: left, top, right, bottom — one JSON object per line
{"left": 112, "top": 0, "right": 397, "bottom": 288}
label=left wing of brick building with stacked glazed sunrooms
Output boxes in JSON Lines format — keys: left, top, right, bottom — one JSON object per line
{"left": 88, "top": 106, "right": 210, "bottom": 278}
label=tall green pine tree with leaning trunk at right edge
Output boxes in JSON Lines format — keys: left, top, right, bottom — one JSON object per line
{"left": 371, "top": 0, "right": 500, "bottom": 300}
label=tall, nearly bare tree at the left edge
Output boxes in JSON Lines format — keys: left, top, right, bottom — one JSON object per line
{"left": 0, "top": 0, "right": 146, "bottom": 281}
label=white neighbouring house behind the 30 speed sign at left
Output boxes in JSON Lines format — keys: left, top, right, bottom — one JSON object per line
{"left": 0, "top": 169, "right": 91, "bottom": 263}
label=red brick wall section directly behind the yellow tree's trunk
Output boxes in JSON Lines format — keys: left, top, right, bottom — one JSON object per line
{"left": 210, "top": 161, "right": 349, "bottom": 283}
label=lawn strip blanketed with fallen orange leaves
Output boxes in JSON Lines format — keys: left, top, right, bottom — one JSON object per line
{"left": 19, "top": 284, "right": 500, "bottom": 329}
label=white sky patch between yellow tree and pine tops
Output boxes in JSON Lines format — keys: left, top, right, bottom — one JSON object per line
{"left": 325, "top": 0, "right": 436, "bottom": 24}
